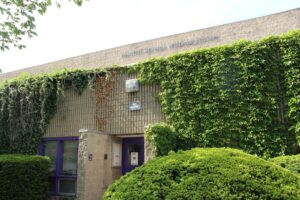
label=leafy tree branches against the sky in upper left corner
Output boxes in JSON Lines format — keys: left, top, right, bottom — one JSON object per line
{"left": 0, "top": 0, "right": 84, "bottom": 51}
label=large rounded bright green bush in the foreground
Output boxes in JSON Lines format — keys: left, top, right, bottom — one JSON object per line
{"left": 104, "top": 148, "right": 300, "bottom": 200}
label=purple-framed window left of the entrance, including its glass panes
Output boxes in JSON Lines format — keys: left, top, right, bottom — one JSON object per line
{"left": 40, "top": 137, "right": 78, "bottom": 196}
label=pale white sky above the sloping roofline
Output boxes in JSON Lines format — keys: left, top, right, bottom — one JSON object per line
{"left": 0, "top": 0, "right": 300, "bottom": 73}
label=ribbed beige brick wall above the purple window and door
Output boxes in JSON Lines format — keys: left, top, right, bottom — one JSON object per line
{"left": 44, "top": 73, "right": 164, "bottom": 137}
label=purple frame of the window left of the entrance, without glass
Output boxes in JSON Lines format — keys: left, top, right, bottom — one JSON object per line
{"left": 39, "top": 137, "right": 79, "bottom": 196}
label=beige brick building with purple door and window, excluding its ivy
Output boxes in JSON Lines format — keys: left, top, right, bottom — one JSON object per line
{"left": 0, "top": 8, "right": 300, "bottom": 200}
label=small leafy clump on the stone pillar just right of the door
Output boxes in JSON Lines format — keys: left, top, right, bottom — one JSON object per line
{"left": 145, "top": 123, "right": 179, "bottom": 156}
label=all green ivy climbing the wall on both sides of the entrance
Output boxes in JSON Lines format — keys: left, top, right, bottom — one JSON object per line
{"left": 0, "top": 31, "right": 300, "bottom": 157}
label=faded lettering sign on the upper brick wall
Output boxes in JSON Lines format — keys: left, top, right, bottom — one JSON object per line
{"left": 122, "top": 36, "right": 219, "bottom": 58}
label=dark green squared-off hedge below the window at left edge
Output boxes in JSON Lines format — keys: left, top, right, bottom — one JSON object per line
{"left": 0, "top": 155, "right": 50, "bottom": 200}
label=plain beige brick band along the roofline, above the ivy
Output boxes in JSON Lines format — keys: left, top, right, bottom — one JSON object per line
{"left": 0, "top": 8, "right": 300, "bottom": 81}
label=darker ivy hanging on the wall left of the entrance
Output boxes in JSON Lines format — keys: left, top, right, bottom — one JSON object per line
{"left": 0, "top": 69, "right": 106, "bottom": 154}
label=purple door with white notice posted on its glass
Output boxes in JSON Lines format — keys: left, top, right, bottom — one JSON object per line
{"left": 122, "top": 137, "right": 144, "bottom": 175}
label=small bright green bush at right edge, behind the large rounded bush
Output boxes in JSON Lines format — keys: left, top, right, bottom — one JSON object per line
{"left": 270, "top": 154, "right": 300, "bottom": 174}
